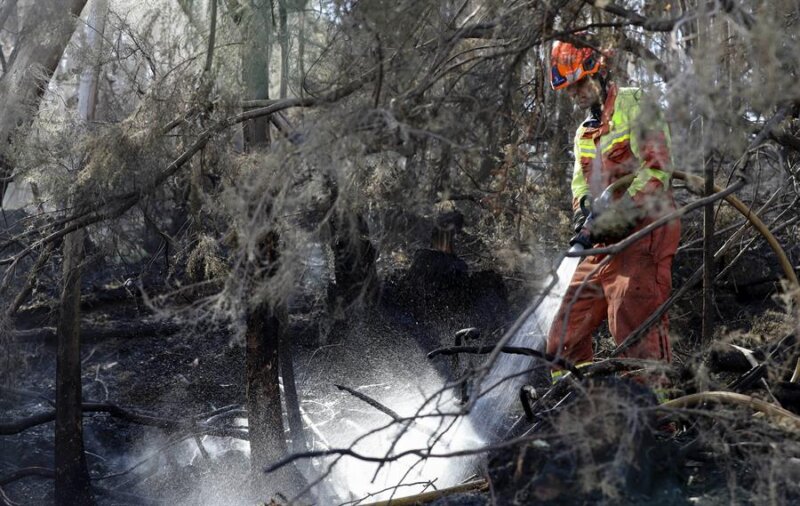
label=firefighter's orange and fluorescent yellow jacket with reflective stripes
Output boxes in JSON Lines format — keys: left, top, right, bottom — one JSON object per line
{"left": 572, "top": 83, "right": 672, "bottom": 210}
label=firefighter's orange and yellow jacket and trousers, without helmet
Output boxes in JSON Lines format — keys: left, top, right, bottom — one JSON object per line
{"left": 547, "top": 83, "right": 680, "bottom": 364}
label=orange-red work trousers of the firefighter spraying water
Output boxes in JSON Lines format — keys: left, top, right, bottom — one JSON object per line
{"left": 547, "top": 221, "right": 680, "bottom": 363}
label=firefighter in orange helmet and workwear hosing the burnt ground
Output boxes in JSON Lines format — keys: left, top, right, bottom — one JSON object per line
{"left": 547, "top": 35, "right": 680, "bottom": 376}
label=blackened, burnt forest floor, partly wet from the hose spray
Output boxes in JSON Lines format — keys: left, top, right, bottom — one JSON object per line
{"left": 0, "top": 231, "right": 800, "bottom": 505}
